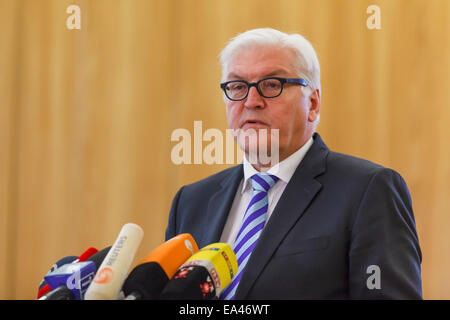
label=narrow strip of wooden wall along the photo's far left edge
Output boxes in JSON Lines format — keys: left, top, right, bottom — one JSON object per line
{"left": 0, "top": 2, "right": 20, "bottom": 298}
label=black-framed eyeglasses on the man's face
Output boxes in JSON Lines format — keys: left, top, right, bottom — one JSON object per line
{"left": 220, "top": 77, "right": 308, "bottom": 101}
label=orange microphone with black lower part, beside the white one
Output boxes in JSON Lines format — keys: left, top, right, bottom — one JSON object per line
{"left": 122, "top": 233, "right": 198, "bottom": 300}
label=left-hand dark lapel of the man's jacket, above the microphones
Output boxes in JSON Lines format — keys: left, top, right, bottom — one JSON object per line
{"left": 199, "top": 164, "right": 244, "bottom": 247}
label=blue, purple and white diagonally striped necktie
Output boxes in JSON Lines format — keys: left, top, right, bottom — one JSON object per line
{"left": 220, "top": 173, "right": 278, "bottom": 300}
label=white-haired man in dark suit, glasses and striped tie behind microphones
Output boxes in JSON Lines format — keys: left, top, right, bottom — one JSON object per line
{"left": 166, "top": 29, "right": 422, "bottom": 299}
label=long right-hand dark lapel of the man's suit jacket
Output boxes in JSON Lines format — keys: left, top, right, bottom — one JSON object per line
{"left": 235, "top": 134, "right": 329, "bottom": 300}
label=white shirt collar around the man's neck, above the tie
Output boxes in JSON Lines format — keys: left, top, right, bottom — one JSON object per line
{"left": 241, "top": 137, "right": 314, "bottom": 193}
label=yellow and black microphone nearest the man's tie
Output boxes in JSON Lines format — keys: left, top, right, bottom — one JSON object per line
{"left": 160, "top": 243, "right": 238, "bottom": 300}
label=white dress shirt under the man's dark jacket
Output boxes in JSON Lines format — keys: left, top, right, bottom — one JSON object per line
{"left": 220, "top": 137, "right": 313, "bottom": 247}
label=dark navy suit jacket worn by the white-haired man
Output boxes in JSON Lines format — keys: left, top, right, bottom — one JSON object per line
{"left": 166, "top": 133, "right": 422, "bottom": 299}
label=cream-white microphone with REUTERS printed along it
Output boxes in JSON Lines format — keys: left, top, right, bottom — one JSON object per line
{"left": 84, "top": 223, "right": 144, "bottom": 300}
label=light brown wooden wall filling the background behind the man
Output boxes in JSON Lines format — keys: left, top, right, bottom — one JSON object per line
{"left": 0, "top": 0, "right": 450, "bottom": 299}
